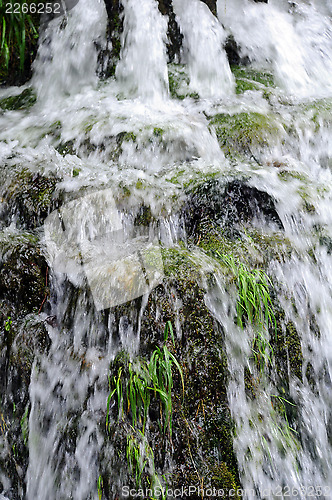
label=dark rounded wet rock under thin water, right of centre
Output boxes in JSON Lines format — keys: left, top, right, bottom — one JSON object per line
{"left": 184, "top": 180, "right": 283, "bottom": 236}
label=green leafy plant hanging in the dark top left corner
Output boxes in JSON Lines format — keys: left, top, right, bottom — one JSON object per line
{"left": 0, "top": 0, "right": 38, "bottom": 72}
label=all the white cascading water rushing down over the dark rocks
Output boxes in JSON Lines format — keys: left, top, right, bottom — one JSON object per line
{"left": 0, "top": 0, "right": 332, "bottom": 500}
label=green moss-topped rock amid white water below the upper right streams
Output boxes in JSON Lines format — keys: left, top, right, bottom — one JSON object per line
{"left": 209, "top": 112, "right": 284, "bottom": 158}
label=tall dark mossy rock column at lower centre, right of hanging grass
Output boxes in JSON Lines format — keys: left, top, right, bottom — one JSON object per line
{"left": 137, "top": 248, "right": 239, "bottom": 488}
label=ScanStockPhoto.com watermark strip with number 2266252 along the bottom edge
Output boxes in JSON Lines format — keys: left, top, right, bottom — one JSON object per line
{"left": 122, "top": 485, "right": 332, "bottom": 499}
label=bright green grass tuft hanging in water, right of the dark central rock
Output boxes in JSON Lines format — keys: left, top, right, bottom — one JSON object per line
{"left": 217, "top": 252, "right": 277, "bottom": 369}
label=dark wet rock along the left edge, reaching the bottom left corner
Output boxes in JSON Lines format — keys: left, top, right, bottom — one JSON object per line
{"left": 0, "top": 301, "right": 50, "bottom": 500}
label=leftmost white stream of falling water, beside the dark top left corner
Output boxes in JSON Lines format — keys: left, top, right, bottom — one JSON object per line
{"left": 33, "top": 0, "right": 106, "bottom": 106}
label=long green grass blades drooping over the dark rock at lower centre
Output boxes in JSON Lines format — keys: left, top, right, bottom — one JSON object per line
{"left": 106, "top": 321, "right": 184, "bottom": 492}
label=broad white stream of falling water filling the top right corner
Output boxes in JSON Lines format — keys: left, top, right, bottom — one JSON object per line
{"left": 218, "top": 0, "right": 332, "bottom": 97}
